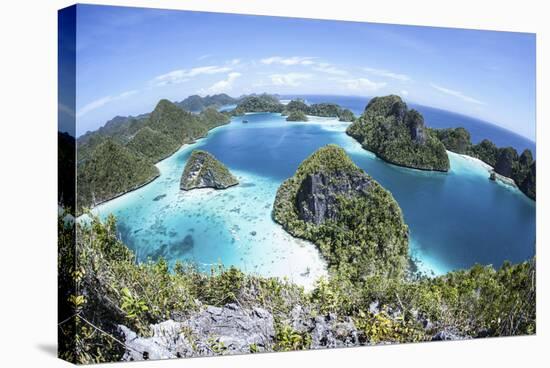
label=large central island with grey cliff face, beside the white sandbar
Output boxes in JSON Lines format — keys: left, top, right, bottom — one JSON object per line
{"left": 273, "top": 145, "right": 408, "bottom": 283}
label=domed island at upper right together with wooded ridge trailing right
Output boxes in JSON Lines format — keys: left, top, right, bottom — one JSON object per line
{"left": 346, "top": 95, "right": 536, "bottom": 200}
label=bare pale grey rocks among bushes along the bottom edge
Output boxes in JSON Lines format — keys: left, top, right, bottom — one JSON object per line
{"left": 119, "top": 303, "right": 468, "bottom": 361}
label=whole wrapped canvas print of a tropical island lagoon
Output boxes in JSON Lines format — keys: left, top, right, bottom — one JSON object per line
{"left": 58, "top": 5, "right": 536, "bottom": 364}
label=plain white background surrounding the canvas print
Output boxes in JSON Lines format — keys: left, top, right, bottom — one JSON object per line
{"left": 0, "top": 0, "right": 550, "bottom": 368}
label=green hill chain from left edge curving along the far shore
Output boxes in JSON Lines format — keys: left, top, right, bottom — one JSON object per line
{"left": 77, "top": 94, "right": 362, "bottom": 212}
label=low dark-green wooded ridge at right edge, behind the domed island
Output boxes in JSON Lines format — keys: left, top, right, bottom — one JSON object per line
{"left": 430, "top": 128, "right": 536, "bottom": 200}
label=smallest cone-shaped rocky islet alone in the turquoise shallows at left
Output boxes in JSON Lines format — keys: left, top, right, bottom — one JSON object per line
{"left": 180, "top": 150, "right": 239, "bottom": 190}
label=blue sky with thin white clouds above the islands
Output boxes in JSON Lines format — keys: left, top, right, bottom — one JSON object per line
{"left": 67, "top": 5, "right": 536, "bottom": 140}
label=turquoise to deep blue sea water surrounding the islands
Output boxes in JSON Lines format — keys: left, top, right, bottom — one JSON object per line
{"left": 94, "top": 96, "right": 535, "bottom": 287}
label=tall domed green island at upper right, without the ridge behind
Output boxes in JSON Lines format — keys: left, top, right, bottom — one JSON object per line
{"left": 352, "top": 95, "right": 449, "bottom": 171}
